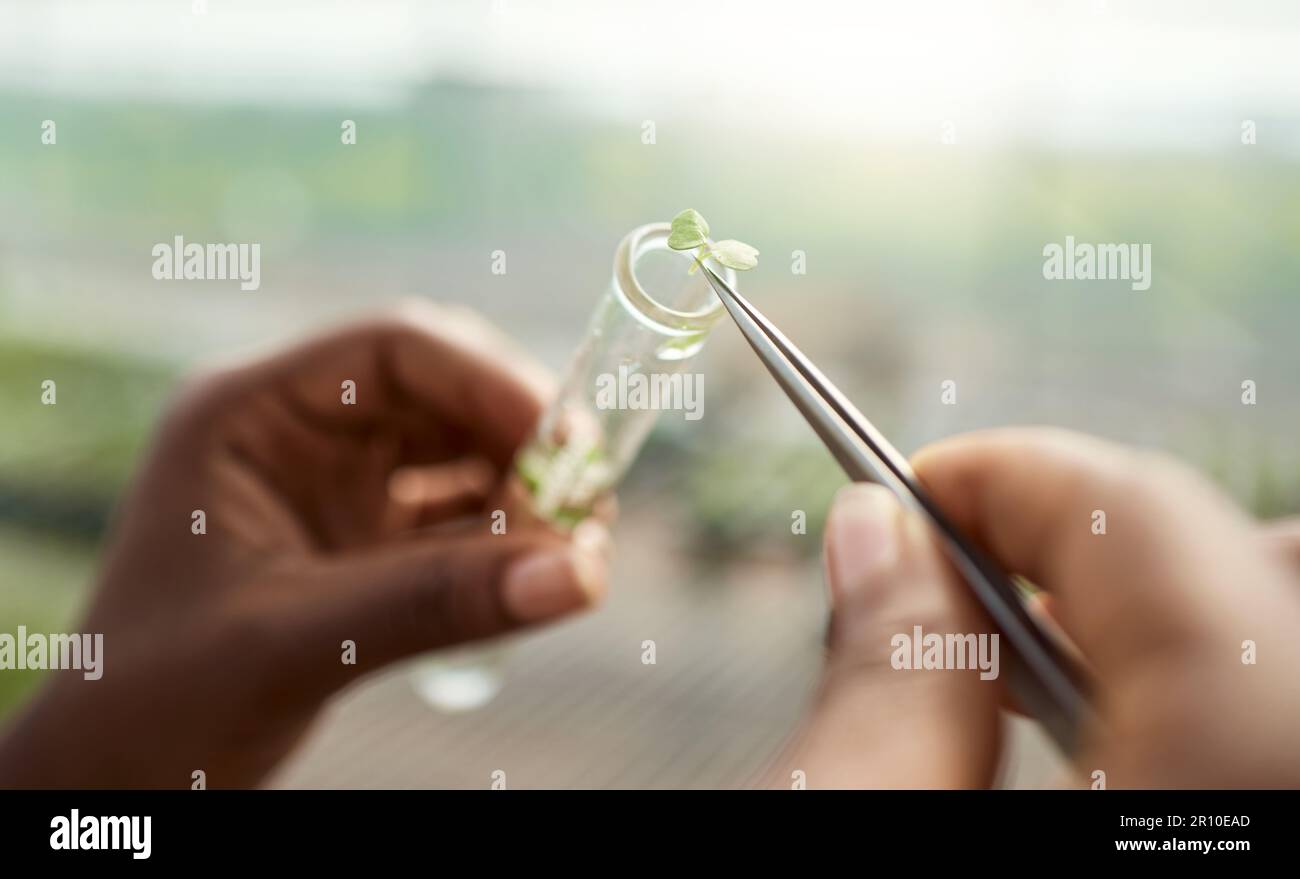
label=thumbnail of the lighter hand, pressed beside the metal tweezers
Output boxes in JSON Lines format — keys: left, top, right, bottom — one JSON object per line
{"left": 826, "top": 482, "right": 898, "bottom": 599}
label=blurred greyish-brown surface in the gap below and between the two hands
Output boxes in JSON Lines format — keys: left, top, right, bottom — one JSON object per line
{"left": 272, "top": 515, "right": 1060, "bottom": 788}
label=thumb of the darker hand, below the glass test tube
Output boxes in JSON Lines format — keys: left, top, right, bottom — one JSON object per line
{"left": 275, "top": 514, "right": 608, "bottom": 689}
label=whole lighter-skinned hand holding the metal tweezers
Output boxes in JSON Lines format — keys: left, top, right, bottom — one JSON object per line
{"left": 770, "top": 429, "right": 1300, "bottom": 788}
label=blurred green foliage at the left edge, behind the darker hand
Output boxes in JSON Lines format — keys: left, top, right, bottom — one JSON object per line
{"left": 0, "top": 339, "right": 172, "bottom": 716}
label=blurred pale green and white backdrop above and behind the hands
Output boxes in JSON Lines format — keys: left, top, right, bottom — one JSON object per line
{"left": 0, "top": 3, "right": 1300, "bottom": 733}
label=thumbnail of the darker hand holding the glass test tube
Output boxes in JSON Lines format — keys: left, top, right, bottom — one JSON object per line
{"left": 502, "top": 546, "right": 601, "bottom": 623}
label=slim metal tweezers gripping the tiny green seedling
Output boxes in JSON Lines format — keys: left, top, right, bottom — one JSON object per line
{"left": 703, "top": 267, "right": 1095, "bottom": 754}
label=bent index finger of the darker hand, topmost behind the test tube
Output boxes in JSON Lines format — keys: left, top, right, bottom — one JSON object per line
{"left": 179, "top": 300, "right": 553, "bottom": 466}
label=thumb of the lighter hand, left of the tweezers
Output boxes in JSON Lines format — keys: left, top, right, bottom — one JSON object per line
{"left": 764, "top": 484, "right": 1000, "bottom": 788}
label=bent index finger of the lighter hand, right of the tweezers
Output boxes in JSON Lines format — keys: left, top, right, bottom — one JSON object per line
{"left": 914, "top": 429, "right": 1278, "bottom": 677}
